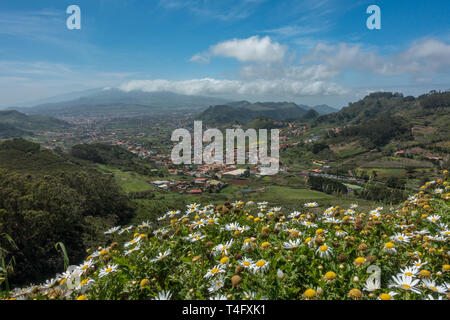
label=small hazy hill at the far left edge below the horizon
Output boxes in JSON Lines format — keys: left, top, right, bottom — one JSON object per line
{"left": 0, "top": 110, "right": 70, "bottom": 132}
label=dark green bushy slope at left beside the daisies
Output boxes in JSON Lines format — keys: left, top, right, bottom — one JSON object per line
{"left": 0, "top": 139, "right": 134, "bottom": 283}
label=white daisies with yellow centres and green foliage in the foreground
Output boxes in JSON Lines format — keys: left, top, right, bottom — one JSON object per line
{"left": 5, "top": 171, "right": 450, "bottom": 300}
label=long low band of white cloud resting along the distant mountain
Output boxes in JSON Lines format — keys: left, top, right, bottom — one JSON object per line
{"left": 119, "top": 78, "right": 347, "bottom": 97}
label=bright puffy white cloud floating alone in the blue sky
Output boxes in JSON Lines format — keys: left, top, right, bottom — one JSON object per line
{"left": 191, "top": 36, "right": 287, "bottom": 63}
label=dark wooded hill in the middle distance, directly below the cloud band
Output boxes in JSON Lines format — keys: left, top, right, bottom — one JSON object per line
{"left": 197, "top": 101, "right": 308, "bottom": 125}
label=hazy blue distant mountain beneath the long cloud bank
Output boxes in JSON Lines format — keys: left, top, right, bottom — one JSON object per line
{"left": 20, "top": 88, "right": 227, "bottom": 116}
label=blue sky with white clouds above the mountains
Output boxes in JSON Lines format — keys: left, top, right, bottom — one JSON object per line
{"left": 0, "top": 0, "right": 450, "bottom": 107}
